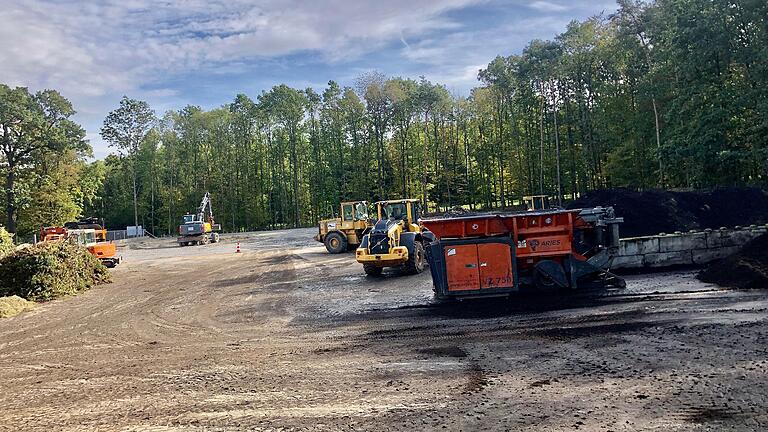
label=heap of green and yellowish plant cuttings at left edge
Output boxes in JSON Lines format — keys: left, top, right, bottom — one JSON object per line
{"left": 0, "top": 242, "right": 111, "bottom": 301}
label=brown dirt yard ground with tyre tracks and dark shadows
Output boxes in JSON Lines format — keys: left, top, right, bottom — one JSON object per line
{"left": 0, "top": 229, "right": 768, "bottom": 431}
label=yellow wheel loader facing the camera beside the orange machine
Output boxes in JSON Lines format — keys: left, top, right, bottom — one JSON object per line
{"left": 355, "top": 199, "right": 435, "bottom": 276}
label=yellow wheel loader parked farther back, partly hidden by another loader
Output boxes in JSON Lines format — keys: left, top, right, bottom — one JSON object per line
{"left": 315, "top": 201, "right": 372, "bottom": 254}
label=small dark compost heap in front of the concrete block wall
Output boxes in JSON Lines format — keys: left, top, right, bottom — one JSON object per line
{"left": 698, "top": 234, "right": 768, "bottom": 289}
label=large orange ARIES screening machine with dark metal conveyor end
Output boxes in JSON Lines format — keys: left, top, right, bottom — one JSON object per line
{"left": 422, "top": 207, "right": 625, "bottom": 299}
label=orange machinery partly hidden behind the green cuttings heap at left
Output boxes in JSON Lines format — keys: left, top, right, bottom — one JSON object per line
{"left": 40, "top": 218, "right": 123, "bottom": 268}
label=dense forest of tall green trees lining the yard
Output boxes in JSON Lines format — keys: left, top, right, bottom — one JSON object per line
{"left": 0, "top": 0, "right": 768, "bottom": 235}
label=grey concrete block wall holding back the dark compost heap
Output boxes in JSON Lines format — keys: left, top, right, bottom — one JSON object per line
{"left": 611, "top": 225, "right": 768, "bottom": 269}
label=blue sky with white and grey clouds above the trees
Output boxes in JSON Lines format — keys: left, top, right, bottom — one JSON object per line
{"left": 0, "top": 0, "right": 616, "bottom": 159}
